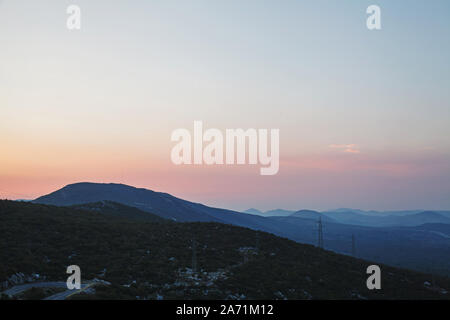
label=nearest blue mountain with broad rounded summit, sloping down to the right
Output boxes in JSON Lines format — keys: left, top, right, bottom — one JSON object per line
{"left": 33, "top": 182, "right": 302, "bottom": 236}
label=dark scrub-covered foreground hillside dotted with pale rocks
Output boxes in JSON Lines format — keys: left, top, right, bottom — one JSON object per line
{"left": 0, "top": 201, "right": 450, "bottom": 299}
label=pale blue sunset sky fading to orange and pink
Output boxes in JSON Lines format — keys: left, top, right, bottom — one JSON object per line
{"left": 0, "top": 0, "right": 450, "bottom": 210}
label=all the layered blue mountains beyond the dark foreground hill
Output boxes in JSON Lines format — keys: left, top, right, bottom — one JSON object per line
{"left": 34, "top": 183, "right": 450, "bottom": 275}
